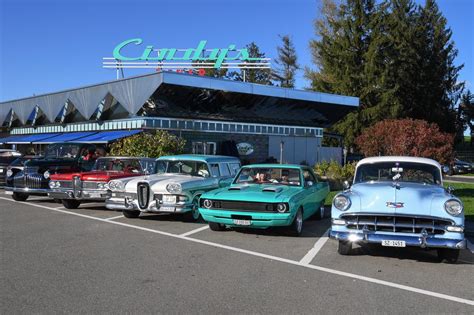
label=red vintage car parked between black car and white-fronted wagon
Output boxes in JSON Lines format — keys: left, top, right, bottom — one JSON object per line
{"left": 48, "top": 157, "right": 156, "bottom": 209}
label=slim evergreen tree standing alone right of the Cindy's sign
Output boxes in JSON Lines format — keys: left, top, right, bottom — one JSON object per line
{"left": 273, "top": 35, "right": 300, "bottom": 88}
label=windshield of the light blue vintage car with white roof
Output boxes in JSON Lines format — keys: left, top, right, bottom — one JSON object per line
{"left": 354, "top": 162, "right": 441, "bottom": 185}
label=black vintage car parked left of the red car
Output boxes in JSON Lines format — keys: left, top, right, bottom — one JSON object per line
{"left": 5, "top": 142, "right": 105, "bottom": 201}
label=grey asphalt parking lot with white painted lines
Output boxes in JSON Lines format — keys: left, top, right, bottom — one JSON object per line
{"left": 0, "top": 192, "right": 474, "bottom": 314}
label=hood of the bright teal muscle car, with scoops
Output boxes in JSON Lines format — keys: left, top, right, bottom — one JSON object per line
{"left": 201, "top": 184, "right": 301, "bottom": 202}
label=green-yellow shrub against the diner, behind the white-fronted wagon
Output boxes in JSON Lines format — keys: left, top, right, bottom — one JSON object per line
{"left": 110, "top": 130, "right": 186, "bottom": 158}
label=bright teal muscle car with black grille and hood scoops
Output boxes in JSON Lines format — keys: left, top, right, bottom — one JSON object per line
{"left": 199, "top": 164, "right": 329, "bottom": 236}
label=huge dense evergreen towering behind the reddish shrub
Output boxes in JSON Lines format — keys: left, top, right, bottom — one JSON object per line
{"left": 306, "top": 0, "right": 463, "bottom": 145}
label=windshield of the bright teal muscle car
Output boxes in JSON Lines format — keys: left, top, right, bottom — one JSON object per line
{"left": 234, "top": 167, "right": 301, "bottom": 186}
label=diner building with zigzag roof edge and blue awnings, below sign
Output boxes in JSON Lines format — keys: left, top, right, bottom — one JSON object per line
{"left": 0, "top": 72, "right": 359, "bottom": 165}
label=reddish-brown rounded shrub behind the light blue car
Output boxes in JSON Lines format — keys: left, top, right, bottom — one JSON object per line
{"left": 355, "top": 119, "right": 454, "bottom": 163}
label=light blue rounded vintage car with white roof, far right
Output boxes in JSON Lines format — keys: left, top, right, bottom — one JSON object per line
{"left": 330, "top": 156, "right": 466, "bottom": 263}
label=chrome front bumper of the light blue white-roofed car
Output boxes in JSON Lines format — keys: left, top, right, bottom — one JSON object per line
{"left": 329, "top": 230, "right": 466, "bottom": 249}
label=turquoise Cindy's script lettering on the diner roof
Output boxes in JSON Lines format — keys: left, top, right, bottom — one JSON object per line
{"left": 113, "top": 38, "right": 268, "bottom": 68}
